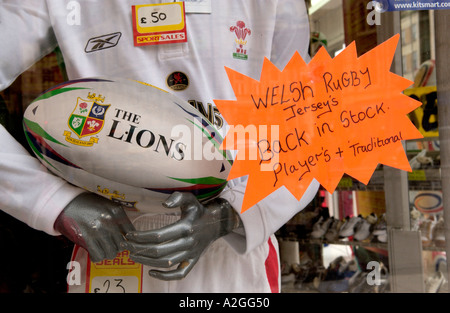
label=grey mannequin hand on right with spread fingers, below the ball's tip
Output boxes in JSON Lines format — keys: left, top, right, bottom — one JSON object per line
{"left": 126, "top": 192, "right": 240, "bottom": 280}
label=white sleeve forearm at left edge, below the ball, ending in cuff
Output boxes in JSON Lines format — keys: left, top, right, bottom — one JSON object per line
{"left": 0, "top": 125, "right": 82, "bottom": 235}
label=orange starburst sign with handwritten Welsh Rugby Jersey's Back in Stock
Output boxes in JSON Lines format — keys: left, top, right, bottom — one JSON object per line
{"left": 214, "top": 35, "right": 422, "bottom": 212}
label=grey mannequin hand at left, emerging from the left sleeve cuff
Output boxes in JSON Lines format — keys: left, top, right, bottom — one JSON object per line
{"left": 54, "top": 193, "right": 135, "bottom": 262}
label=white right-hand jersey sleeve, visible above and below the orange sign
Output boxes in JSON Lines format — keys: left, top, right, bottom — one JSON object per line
{"left": 221, "top": 0, "right": 320, "bottom": 253}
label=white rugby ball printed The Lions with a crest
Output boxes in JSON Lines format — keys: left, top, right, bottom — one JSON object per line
{"left": 23, "top": 78, "right": 232, "bottom": 213}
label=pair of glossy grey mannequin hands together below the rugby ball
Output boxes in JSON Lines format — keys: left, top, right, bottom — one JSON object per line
{"left": 55, "top": 192, "right": 242, "bottom": 280}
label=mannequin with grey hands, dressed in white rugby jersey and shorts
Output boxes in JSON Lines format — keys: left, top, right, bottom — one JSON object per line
{"left": 0, "top": 0, "right": 319, "bottom": 293}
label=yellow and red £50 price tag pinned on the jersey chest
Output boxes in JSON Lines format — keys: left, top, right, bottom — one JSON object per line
{"left": 132, "top": 2, "right": 187, "bottom": 46}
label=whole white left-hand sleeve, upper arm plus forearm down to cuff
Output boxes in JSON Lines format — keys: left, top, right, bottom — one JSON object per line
{"left": 0, "top": 0, "right": 82, "bottom": 235}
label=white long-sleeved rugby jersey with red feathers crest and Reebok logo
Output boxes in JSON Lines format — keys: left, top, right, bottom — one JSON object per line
{"left": 0, "top": 0, "right": 319, "bottom": 253}
